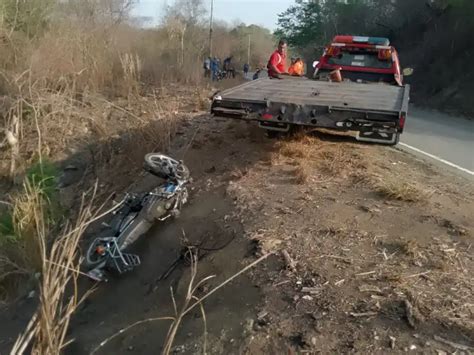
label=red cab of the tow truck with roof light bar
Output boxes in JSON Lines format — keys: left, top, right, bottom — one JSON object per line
{"left": 313, "top": 36, "right": 403, "bottom": 86}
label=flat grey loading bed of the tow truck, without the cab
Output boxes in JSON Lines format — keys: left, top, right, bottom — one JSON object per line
{"left": 211, "top": 76, "right": 410, "bottom": 144}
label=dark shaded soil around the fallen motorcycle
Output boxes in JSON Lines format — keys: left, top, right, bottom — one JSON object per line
{"left": 0, "top": 115, "right": 273, "bottom": 354}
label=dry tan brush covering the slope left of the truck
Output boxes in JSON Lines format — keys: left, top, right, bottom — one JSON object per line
{"left": 0, "top": 0, "right": 273, "bottom": 298}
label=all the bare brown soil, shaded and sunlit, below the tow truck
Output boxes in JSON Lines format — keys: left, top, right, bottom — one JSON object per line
{"left": 0, "top": 105, "right": 474, "bottom": 354}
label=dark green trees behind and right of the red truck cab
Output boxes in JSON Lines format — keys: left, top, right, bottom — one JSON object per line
{"left": 276, "top": 0, "right": 474, "bottom": 112}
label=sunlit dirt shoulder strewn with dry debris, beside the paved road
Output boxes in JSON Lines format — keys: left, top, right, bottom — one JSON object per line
{"left": 231, "top": 129, "right": 474, "bottom": 353}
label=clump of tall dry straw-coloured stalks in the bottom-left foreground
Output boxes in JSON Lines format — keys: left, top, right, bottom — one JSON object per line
{"left": 11, "top": 189, "right": 107, "bottom": 354}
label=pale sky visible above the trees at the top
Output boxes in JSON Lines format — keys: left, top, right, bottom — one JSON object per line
{"left": 134, "top": 0, "right": 294, "bottom": 30}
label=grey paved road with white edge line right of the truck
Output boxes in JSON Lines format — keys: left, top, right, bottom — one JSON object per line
{"left": 400, "top": 106, "right": 474, "bottom": 175}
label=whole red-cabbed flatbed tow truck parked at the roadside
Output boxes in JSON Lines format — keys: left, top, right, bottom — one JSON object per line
{"left": 211, "top": 36, "right": 411, "bottom": 145}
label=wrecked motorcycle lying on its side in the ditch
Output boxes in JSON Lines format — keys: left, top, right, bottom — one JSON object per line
{"left": 84, "top": 153, "right": 190, "bottom": 281}
